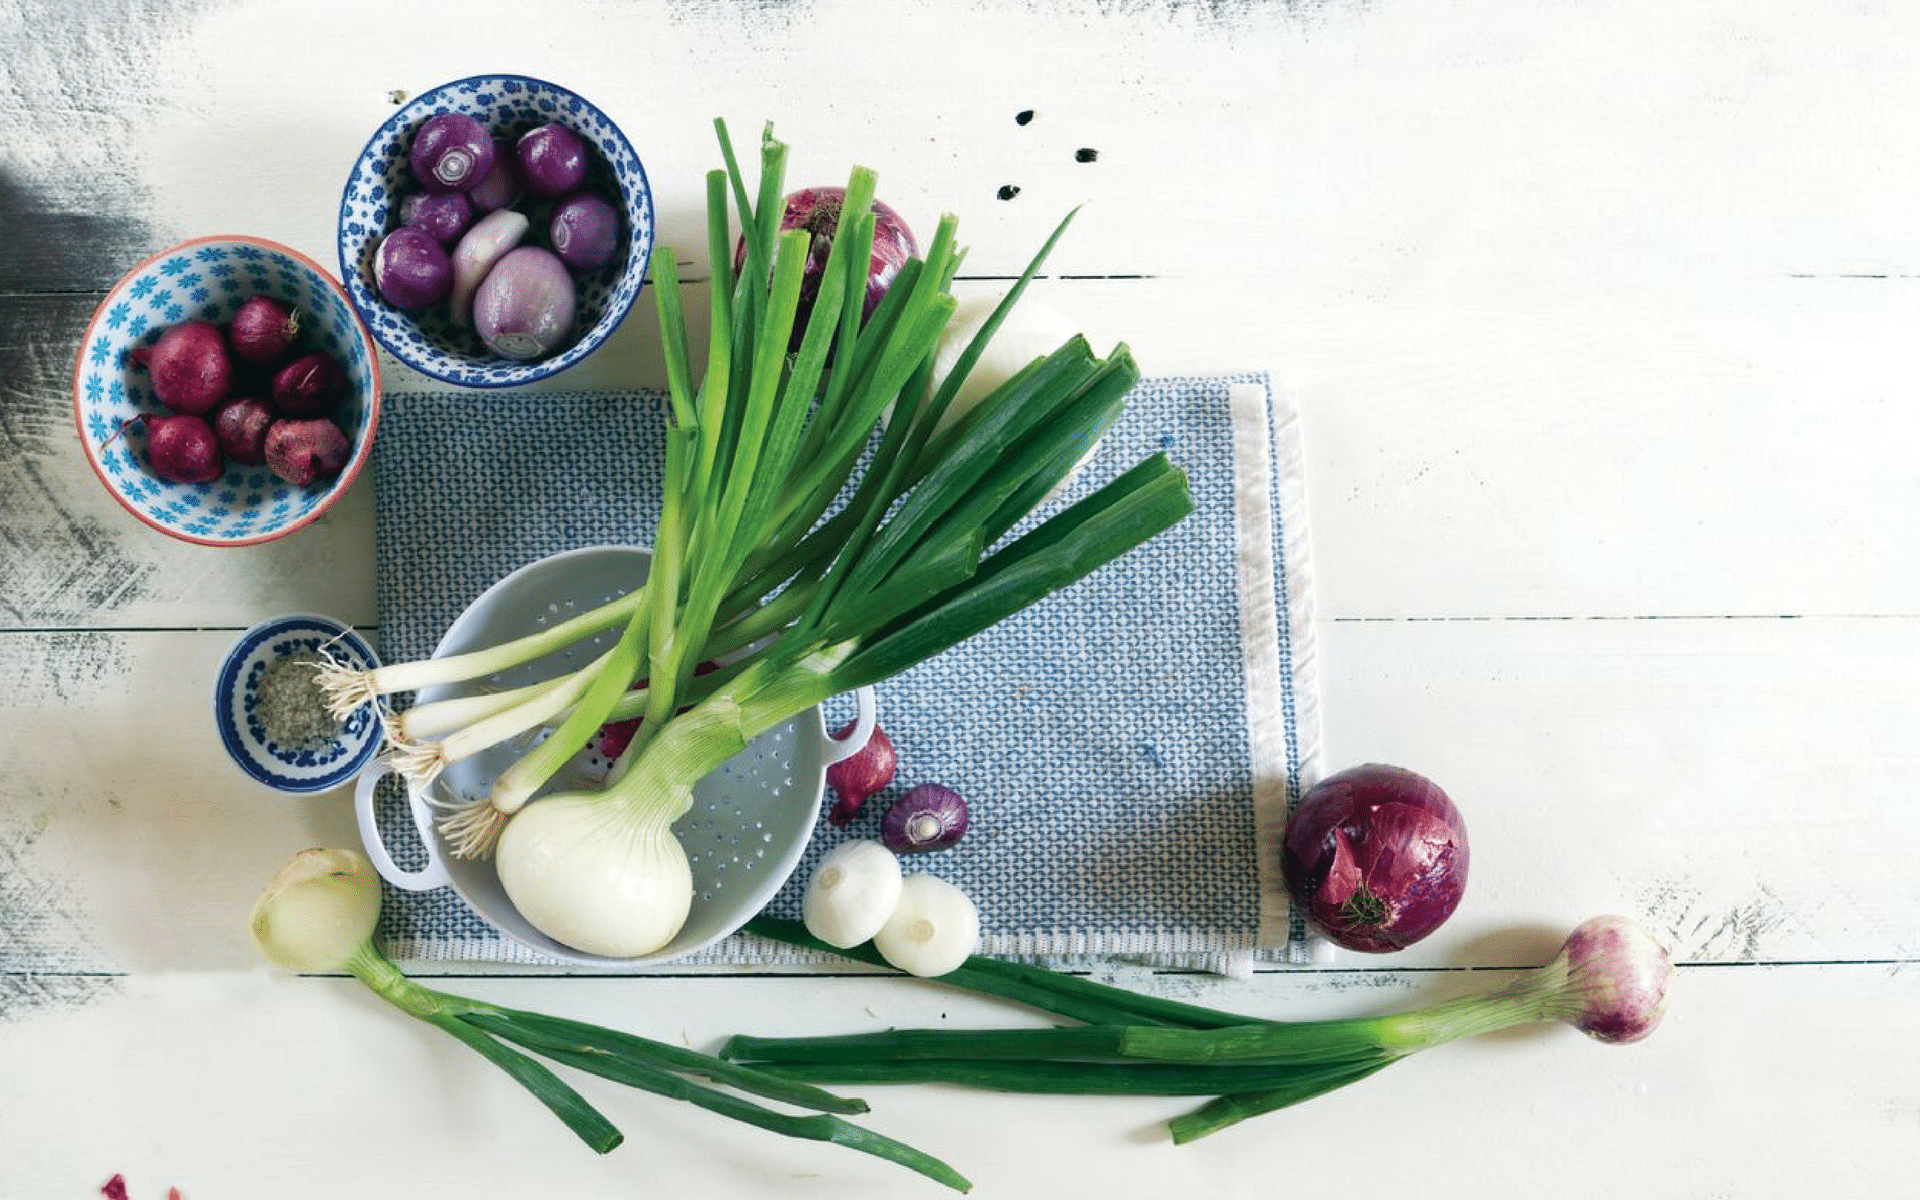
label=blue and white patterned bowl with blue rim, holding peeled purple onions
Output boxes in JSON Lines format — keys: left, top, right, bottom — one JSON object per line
{"left": 340, "top": 75, "right": 653, "bottom": 388}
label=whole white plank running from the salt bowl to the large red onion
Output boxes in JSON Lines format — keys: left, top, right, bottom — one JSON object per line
{"left": 0, "top": 618, "right": 1920, "bottom": 972}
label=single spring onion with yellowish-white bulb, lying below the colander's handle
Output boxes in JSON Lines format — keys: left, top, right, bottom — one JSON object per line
{"left": 250, "top": 849, "right": 972, "bottom": 1192}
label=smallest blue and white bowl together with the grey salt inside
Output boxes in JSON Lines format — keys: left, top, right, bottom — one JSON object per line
{"left": 213, "top": 612, "right": 382, "bottom": 795}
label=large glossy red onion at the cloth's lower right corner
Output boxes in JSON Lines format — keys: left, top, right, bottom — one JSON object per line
{"left": 1281, "top": 762, "right": 1469, "bottom": 954}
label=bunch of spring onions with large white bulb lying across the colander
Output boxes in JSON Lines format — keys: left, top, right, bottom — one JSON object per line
{"left": 323, "top": 123, "right": 1192, "bottom": 958}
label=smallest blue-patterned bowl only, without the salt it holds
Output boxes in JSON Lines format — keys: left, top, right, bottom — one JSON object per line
{"left": 213, "top": 612, "right": 380, "bottom": 795}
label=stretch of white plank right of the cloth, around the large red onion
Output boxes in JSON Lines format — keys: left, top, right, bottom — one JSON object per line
{"left": 1321, "top": 618, "right": 1920, "bottom": 964}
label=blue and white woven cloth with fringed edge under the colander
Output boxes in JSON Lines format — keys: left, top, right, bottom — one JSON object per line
{"left": 374, "top": 374, "right": 1317, "bottom": 970}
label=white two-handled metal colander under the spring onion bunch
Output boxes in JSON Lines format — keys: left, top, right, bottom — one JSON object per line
{"left": 355, "top": 545, "right": 874, "bottom": 966}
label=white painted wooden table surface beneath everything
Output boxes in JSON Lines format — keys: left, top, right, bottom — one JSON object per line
{"left": 0, "top": 0, "right": 1920, "bottom": 1200}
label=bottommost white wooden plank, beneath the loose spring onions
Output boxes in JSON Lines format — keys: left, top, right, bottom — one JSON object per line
{"left": 0, "top": 966, "right": 1920, "bottom": 1200}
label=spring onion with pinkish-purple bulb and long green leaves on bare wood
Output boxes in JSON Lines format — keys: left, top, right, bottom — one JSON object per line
{"left": 720, "top": 916, "right": 1672, "bottom": 1142}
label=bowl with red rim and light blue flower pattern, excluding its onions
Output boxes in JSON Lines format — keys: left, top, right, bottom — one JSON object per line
{"left": 73, "top": 234, "right": 380, "bottom": 545}
